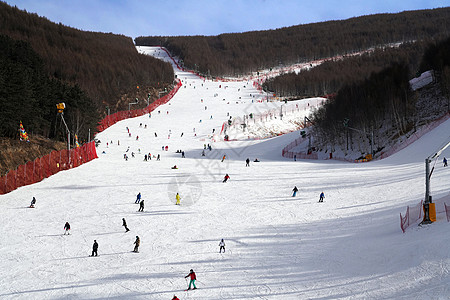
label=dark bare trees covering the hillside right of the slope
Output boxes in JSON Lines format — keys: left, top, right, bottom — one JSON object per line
{"left": 312, "top": 38, "right": 450, "bottom": 154}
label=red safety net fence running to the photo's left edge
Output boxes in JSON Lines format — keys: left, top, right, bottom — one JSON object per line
{"left": 0, "top": 141, "right": 97, "bottom": 194}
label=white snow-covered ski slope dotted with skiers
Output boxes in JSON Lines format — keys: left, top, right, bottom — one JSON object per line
{"left": 0, "top": 45, "right": 450, "bottom": 299}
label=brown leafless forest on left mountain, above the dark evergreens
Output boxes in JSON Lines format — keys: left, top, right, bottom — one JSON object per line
{"left": 0, "top": 2, "right": 174, "bottom": 122}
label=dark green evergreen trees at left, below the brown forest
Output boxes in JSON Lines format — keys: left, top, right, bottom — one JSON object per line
{"left": 0, "top": 35, "right": 99, "bottom": 140}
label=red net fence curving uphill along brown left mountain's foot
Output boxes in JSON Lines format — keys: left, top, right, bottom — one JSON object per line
{"left": 97, "top": 81, "right": 181, "bottom": 132}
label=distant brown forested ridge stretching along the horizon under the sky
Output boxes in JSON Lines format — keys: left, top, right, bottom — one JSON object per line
{"left": 135, "top": 7, "right": 450, "bottom": 76}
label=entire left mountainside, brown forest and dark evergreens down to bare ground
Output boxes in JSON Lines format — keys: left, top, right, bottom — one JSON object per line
{"left": 0, "top": 2, "right": 174, "bottom": 175}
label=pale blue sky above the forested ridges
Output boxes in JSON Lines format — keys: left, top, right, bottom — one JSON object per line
{"left": 6, "top": 0, "right": 450, "bottom": 38}
